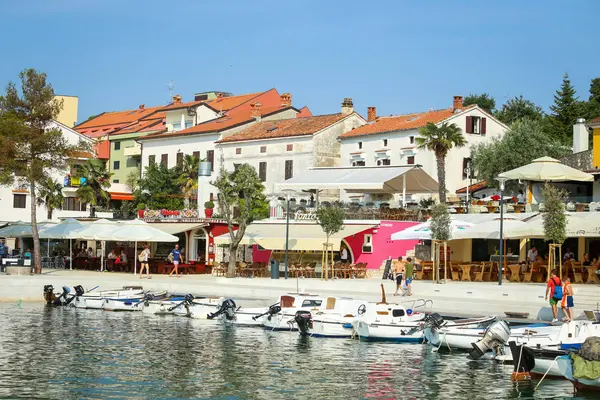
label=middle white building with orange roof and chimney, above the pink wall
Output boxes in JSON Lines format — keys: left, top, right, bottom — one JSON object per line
{"left": 218, "top": 99, "right": 366, "bottom": 197}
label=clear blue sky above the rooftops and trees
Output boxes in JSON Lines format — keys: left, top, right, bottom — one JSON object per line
{"left": 0, "top": 0, "right": 600, "bottom": 121}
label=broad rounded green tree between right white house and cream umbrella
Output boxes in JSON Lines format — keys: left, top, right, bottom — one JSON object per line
{"left": 471, "top": 119, "right": 571, "bottom": 188}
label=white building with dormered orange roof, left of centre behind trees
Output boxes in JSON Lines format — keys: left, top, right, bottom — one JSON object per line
{"left": 138, "top": 89, "right": 303, "bottom": 208}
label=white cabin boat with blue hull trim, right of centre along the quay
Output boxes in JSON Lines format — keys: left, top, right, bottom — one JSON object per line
{"left": 352, "top": 284, "right": 433, "bottom": 343}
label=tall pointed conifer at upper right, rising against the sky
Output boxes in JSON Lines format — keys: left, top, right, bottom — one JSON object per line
{"left": 550, "top": 74, "right": 581, "bottom": 145}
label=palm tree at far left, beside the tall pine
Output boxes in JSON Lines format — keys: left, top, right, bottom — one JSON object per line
{"left": 77, "top": 160, "right": 113, "bottom": 217}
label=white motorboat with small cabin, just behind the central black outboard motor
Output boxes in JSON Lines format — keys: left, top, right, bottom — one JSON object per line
{"left": 263, "top": 293, "right": 327, "bottom": 331}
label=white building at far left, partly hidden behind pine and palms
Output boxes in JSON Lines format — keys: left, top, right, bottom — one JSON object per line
{"left": 0, "top": 121, "right": 112, "bottom": 227}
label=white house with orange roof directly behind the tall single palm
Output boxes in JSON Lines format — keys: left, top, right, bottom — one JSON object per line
{"left": 340, "top": 96, "right": 507, "bottom": 201}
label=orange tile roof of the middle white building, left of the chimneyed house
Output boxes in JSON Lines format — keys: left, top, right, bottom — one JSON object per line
{"left": 221, "top": 114, "right": 347, "bottom": 143}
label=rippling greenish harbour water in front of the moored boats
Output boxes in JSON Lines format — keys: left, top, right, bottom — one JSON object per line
{"left": 0, "top": 304, "right": 593, "bottom": 399}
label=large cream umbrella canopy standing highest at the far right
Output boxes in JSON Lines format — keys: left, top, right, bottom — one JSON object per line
{"left": 499, "top": 157, "right": 594, "bottom": 182}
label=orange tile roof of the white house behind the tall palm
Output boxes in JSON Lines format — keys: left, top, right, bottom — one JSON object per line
{"left": 340, "top": 106, "right": 471, "bottom": 138}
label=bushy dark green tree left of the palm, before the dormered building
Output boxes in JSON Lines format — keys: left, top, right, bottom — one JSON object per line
{"left": 134, "top": 164, "right": 183, "bottom": 210}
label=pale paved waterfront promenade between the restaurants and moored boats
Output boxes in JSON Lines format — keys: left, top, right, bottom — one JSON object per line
{"left": 0, "top": 270, "right": 600, "bottom": 319}
